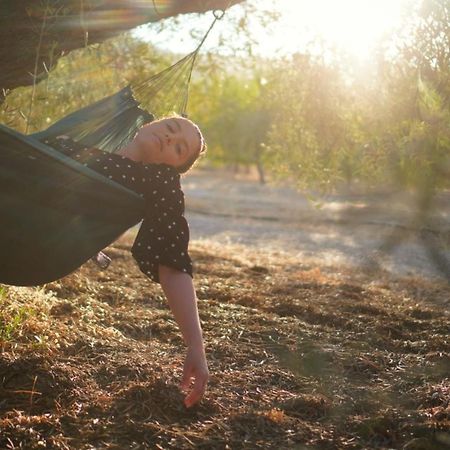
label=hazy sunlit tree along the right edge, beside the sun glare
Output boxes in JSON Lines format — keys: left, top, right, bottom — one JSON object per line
{"left": 372, "top": 0, "right": 450, "bottom": 191}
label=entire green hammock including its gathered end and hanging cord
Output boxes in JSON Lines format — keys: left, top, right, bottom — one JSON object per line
{"left": 0, "top": 14, "right": 222, "bottom": 286}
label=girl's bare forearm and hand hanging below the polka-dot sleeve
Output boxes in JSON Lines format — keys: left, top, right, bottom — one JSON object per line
{"left": 159, "top": 265, "right": 209, "bottom": 408}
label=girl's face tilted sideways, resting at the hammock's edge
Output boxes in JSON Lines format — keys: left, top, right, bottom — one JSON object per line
{"left": 135, "top": 117, "right": 201, "bottom": 167}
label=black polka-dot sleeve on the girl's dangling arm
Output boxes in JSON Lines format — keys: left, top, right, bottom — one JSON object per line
{"left": 132, "top": 167, "right": 192, "bottom": 283}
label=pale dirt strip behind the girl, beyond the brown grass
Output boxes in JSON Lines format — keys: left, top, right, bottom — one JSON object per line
{"left": 183, "top": 171, "right": 450, "bottom": 279}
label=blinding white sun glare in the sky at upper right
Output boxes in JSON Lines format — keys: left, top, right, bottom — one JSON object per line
{"left": 261, "top": 0, "right": 412, "bottom": 59}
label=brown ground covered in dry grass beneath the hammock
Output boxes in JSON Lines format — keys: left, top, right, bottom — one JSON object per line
{"left": 0, "top": 174, "right": 450, "bottom": 450}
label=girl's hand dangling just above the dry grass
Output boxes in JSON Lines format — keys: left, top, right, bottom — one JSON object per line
{"left": 181, "top": 345, "right": 209, "bottom": 408}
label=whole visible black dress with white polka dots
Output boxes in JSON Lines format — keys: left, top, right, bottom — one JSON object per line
{"left": 45, "top": 136, "right": 192, "bottom": 283}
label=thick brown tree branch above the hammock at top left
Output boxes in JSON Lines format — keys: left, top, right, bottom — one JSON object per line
{"left": 0, "top": 0, "right": 245, "bottom": 94}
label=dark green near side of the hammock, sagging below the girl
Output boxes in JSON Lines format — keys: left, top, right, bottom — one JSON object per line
{"left": 0, "top": 125, "right": 144, "bottom": 286}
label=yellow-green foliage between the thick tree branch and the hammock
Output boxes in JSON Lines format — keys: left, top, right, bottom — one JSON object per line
{"left": 0, "top": 35, "right": 173, "bottom": 133}
